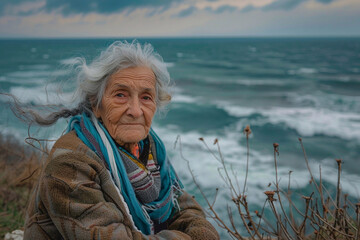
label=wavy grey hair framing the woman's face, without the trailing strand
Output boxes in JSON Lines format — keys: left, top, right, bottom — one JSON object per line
{"left": 76, "top": 41, "right": 171, "bottom": 108}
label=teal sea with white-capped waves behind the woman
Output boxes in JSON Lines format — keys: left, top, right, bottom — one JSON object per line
{"left": 0, "top": 38, "right": 360, "bottom": 239}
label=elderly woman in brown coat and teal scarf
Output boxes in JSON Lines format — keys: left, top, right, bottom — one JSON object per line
{"left": 24, "top": 42, "right": 219, "bottom": 240}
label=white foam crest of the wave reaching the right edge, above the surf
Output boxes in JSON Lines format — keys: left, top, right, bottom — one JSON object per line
{"left": 217, "top": 104, "right": 360, "bottom": 141}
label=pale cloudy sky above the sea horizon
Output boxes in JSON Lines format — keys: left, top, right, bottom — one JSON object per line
{"left": 0, "top": 0, "right": 360, "bottom": 38}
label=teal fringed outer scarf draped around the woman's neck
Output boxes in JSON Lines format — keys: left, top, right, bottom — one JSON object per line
{"left": 68, "top": 113, "right": 183, "bottom": 235}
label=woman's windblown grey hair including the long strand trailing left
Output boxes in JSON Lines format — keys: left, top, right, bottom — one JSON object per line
{"left": 8, "top": 41, "right": 171, "bottom": 126}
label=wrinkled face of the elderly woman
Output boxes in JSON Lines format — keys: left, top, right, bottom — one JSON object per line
{"left": 93, "top": 67, "right": 156, "bottom": 145}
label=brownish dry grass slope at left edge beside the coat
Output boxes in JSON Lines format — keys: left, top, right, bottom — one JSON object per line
{"left": 0, "top": 136, "right": 41, "bottom": 239}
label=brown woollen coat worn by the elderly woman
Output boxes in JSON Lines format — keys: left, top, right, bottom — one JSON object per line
{"left": 24, "top": 132, "right": 219, "bottom": 240}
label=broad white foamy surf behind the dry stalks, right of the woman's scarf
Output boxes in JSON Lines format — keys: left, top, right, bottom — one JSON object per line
{"left": 155, "top": 123, "right": 360, "bottom": 209}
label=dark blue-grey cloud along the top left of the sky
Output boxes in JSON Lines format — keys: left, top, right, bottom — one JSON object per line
{"left": 0, "top": 0, "right": 183, "bottom": 16}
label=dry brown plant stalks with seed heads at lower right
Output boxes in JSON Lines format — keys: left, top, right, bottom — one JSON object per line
{"left": 178, "top": 126, "right": 360, "bottom": 240}
